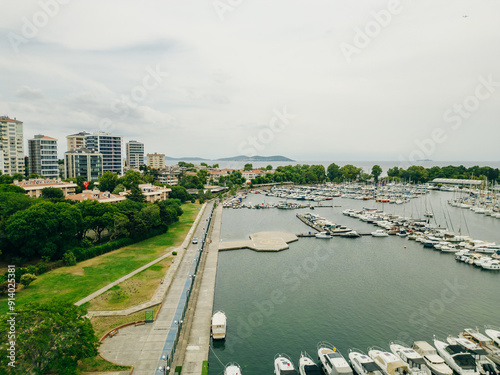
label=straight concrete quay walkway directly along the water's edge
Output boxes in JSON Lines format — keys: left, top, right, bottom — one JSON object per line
{"left": 176, "top": 205, "right": 222, "bottom": 375}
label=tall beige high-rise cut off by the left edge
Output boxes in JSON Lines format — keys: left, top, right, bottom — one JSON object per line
{"left": 0, "top": 116, "right": 25, "bottom": 176}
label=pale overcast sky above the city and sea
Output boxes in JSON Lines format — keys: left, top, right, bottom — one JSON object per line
{"left": 0, "top": 0, "right": 500, "bottom": 162}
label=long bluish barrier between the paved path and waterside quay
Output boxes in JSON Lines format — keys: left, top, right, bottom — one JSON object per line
{"left": 154, "top": 203, "right": 216, "bottom": 375}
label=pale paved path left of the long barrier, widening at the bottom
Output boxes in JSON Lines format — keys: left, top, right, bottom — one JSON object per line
{"left": 100, "top": 205, "right": 211, "bottom": 375}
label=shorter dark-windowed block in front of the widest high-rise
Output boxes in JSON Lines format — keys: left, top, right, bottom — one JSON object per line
{"left": 64, "top": 148, "right": 103, "bottom": 181}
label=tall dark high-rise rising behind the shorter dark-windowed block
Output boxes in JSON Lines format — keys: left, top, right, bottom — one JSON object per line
{"left": 85, "top": 132, "right": 123, "bottom": 175}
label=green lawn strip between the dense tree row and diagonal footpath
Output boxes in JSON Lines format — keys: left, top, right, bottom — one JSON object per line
{"left": 0, "top": 203, "right": 201, "bottom": 314}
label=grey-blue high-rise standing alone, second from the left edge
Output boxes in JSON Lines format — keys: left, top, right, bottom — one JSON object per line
{"left": 28, "top": 134, "right": 59, "bottom": 178}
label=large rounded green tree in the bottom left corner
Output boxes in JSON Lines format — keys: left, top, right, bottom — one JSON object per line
{"left": 0, "top": 302, "right": 99, "bottom": 375}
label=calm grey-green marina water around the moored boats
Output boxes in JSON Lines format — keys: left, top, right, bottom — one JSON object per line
{"left": 209, "top": 192, "right": 500, "bottom": 375}
